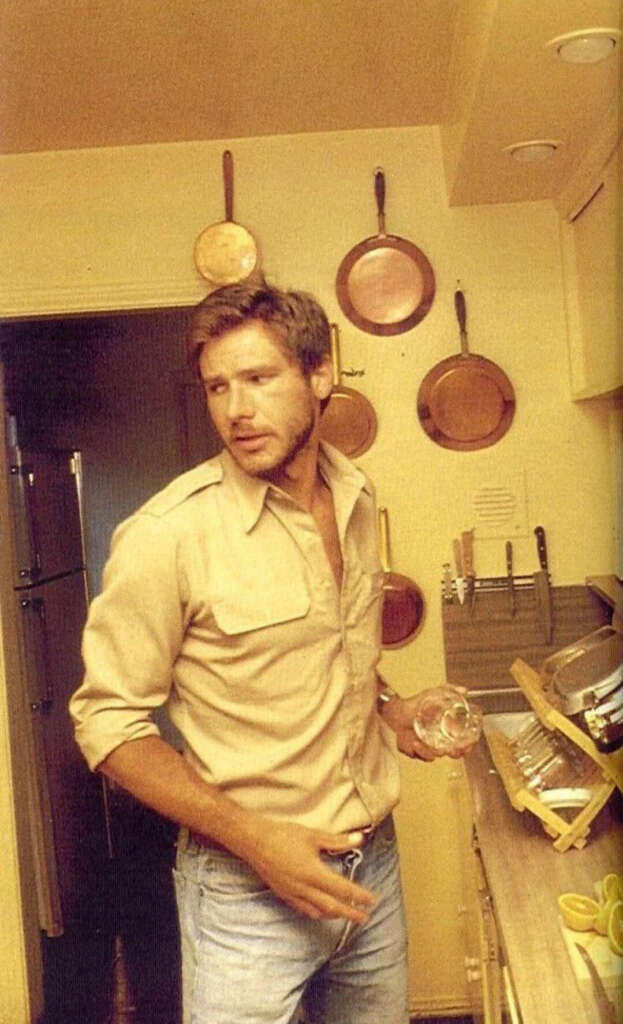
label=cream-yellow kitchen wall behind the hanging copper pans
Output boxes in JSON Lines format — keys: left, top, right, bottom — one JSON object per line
{"left": 0, "top": 128, "right": 614, "bottom": 1011}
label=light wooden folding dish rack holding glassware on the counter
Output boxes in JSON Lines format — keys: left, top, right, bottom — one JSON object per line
{"left": 487, "top": 658, "right": 623, "bottom": 853}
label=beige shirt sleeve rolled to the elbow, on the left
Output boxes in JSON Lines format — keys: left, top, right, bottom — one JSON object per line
{"left": 70, "top": 514, "right": 185, "bottom": 769}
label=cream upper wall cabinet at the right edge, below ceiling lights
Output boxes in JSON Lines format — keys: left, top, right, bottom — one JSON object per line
{"left": 560, "top": 143, "right": 623, "bottom": 398}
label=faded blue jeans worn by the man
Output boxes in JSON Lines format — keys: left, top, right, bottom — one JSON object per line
{"left": 174, "top": 817, "right": 409, "bottom": 1024}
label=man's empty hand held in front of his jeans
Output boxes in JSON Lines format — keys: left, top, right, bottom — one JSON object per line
{"left": 244, "top": 821, "right": 375, "bottom": 925}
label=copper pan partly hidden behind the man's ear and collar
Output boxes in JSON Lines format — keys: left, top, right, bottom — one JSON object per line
{"left": 320, "top": 324, "right": 376, "bottom": 459}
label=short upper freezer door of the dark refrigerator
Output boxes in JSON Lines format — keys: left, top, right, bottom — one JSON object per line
{"left": 9, "top": 449, "right": 84, "bottom": 587}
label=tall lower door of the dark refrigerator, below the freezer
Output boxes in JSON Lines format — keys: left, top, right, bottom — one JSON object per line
{"left": 16, "top": 572, "right": 109, "bottom": 935}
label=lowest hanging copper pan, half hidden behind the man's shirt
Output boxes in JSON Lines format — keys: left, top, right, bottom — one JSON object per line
{"left": 378, "top": 508, "right": 425, "bottom": 648}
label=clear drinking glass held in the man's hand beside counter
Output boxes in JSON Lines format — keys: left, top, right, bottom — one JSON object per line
{"left": 413, "top": 686, "right": 483, "bottom": 754}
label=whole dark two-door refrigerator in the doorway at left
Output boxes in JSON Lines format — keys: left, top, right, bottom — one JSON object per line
{"left": 9, "top": 446, "right": 112, "bottom": 938}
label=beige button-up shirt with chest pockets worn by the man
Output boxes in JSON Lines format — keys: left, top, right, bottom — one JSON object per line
{"left": 70, "top": 445, "right": 399, "bottom": 830}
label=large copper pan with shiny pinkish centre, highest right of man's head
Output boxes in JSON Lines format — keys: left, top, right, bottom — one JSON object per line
{"left": 335, "top": 167, "right": 434, "bottom": 335}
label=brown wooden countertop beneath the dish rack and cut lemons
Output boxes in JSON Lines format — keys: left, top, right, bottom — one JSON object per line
{"left": 465, "top": 738, "right": 623, "bottom": 1024}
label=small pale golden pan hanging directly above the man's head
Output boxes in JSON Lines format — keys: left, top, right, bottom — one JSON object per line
{"left": 194, "top": 150, "right": 257, "bottom": 287}
